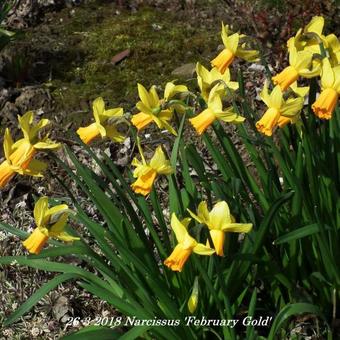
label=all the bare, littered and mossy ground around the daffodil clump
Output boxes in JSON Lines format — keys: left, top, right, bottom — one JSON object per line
{"left": 0, "top": 0, "right": 339, "bottom": 339}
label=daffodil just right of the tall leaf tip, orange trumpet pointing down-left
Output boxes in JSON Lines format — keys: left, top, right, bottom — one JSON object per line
{"left": 189, "top": 84, "right": 245, "bottom": 135}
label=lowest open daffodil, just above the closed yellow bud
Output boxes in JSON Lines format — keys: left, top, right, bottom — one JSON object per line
{"left": 164, "top": 213, "right": 215, "bottom": 272}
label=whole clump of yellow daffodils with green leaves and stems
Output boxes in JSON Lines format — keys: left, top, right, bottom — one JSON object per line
{"left": 0, "top": 16, "right": 340, "bottom": 339}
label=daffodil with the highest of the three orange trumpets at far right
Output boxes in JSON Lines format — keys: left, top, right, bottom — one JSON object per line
{"left": 272, "top": 46, "right": 321, "bottom": 91}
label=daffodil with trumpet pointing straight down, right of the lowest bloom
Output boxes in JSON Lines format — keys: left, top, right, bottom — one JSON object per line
{"left": 188, "top": 201, "right": 253, "bottom": 256}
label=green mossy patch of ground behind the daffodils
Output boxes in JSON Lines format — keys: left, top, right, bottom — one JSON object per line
{"left": 16, "top": 3, "right": 220, "bottom": 122}
